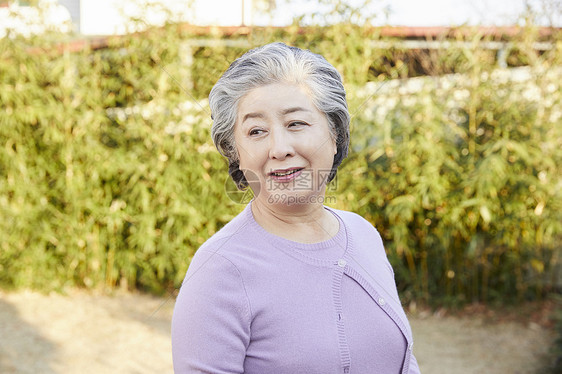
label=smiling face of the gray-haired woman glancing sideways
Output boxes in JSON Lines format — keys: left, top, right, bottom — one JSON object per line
{"left": 234, "top": 83, "right": 337, "bottom": 206}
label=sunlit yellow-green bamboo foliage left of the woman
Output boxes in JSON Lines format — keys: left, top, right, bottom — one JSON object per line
{"left": 0, "top": 28, "right": 239, "bottom": 292}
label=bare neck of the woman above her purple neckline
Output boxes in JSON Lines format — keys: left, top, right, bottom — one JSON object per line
{"left": 252, "top": 199, "right": 339, "bottom": 243}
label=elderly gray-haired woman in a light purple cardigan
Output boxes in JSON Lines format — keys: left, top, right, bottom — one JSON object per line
{"left": 172, "top": 43, "right": 419, "bottom": 374}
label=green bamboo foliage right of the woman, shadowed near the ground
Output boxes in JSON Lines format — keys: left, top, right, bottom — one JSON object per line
{"left": 338, "top": 41, "right": 562, "bottom": 302}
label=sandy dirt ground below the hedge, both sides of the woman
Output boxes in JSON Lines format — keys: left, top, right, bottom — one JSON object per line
{"left": 0, "top": 291, "right": 553, "bottom": 374}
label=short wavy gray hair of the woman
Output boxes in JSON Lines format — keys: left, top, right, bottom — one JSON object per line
{"left": 209, "top": 43, "right": 351, "bottom": 189}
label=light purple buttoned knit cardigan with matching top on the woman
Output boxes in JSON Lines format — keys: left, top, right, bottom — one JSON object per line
{"left": 172, "top": 203, "right": 419, "bottom": 374}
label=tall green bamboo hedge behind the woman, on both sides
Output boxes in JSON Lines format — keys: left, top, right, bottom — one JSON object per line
{"left": 0, "top": 25, "right": 562, "bottom": 303}
